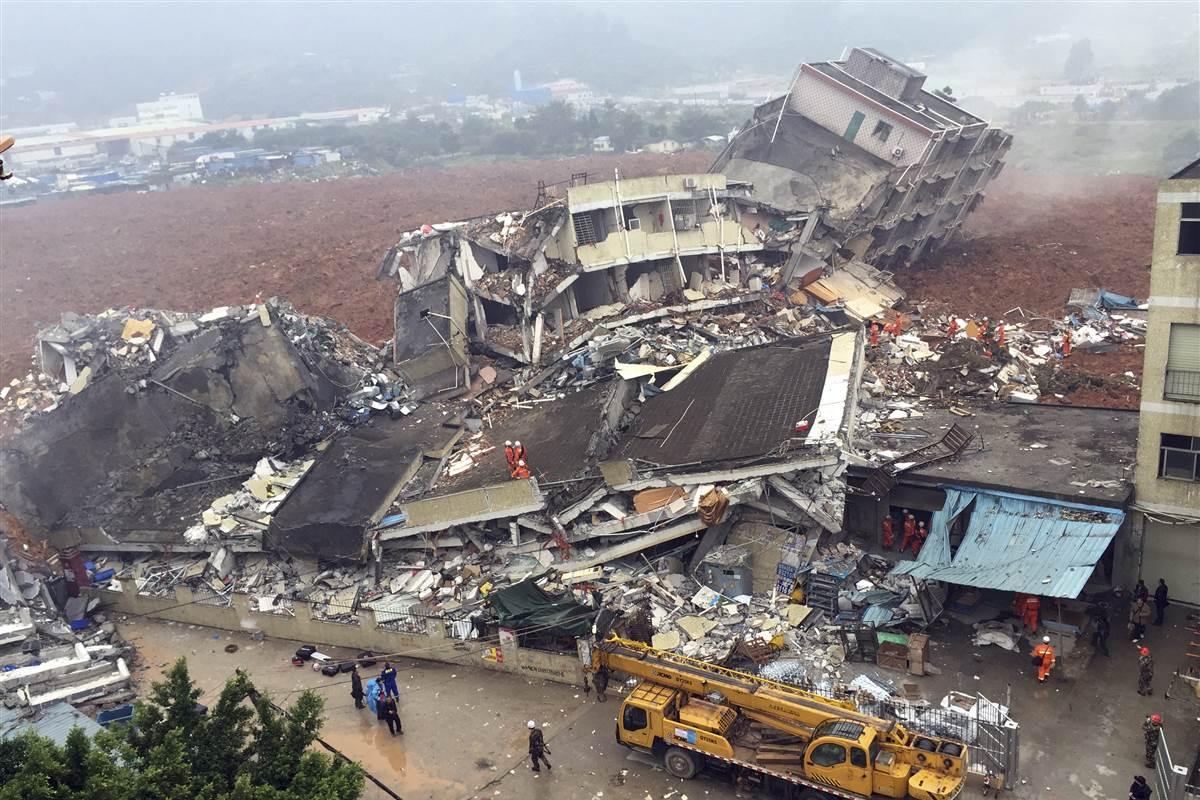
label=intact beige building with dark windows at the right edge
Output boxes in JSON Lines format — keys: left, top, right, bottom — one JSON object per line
{"left": 1134, "top": 160, "right": 1200, "bottom": 604}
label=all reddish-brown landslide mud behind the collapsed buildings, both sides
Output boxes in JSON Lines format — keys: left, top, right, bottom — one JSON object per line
{"left": 0, "top": 159, "right": 1154, "bottom": 408}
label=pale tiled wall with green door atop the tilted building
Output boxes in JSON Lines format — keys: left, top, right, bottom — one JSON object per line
{"left": 788, "top": 66, "right": 931, "bottom": 166}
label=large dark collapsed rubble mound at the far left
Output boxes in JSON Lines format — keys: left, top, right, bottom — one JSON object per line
{"left": 0, "top": 299, "right": 408, "bottom": 551}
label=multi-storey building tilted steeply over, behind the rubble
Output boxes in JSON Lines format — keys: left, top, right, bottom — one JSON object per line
{"left": 713, "top": 48, "right": 1013, "bottom": 269}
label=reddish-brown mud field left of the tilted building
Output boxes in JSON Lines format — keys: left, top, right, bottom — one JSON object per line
{"left": 0, "top": 152, "right": 712, "bottom": 383}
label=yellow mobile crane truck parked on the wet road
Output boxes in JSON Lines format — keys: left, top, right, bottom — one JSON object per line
{"left": 592, "top": 638, "right": 967, "bottom": 800}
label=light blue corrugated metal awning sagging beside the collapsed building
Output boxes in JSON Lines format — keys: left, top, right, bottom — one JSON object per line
{"left": 893, "top": 488, "right": 1124, "bottom": 597}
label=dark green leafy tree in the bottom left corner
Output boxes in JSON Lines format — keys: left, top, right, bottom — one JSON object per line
{"left": 0, "top": 658, "right": 364, "bottom": 800}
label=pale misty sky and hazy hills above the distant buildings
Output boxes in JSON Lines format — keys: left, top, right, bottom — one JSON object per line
{"left": 0, "top": 0, "right": 1200, "bottom": 121}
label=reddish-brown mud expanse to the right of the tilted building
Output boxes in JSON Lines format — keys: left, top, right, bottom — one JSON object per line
{"left": 896, "top": 169, "right": 1156, "bottom": 319}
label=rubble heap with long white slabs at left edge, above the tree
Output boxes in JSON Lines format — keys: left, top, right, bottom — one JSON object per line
{"left": 0, "top": 540, "right": 133, "bottom": 709}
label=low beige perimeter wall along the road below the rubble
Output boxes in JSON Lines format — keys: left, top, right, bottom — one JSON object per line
{"left": 88, "top": 578, "right": 583, "bottom": 685}
